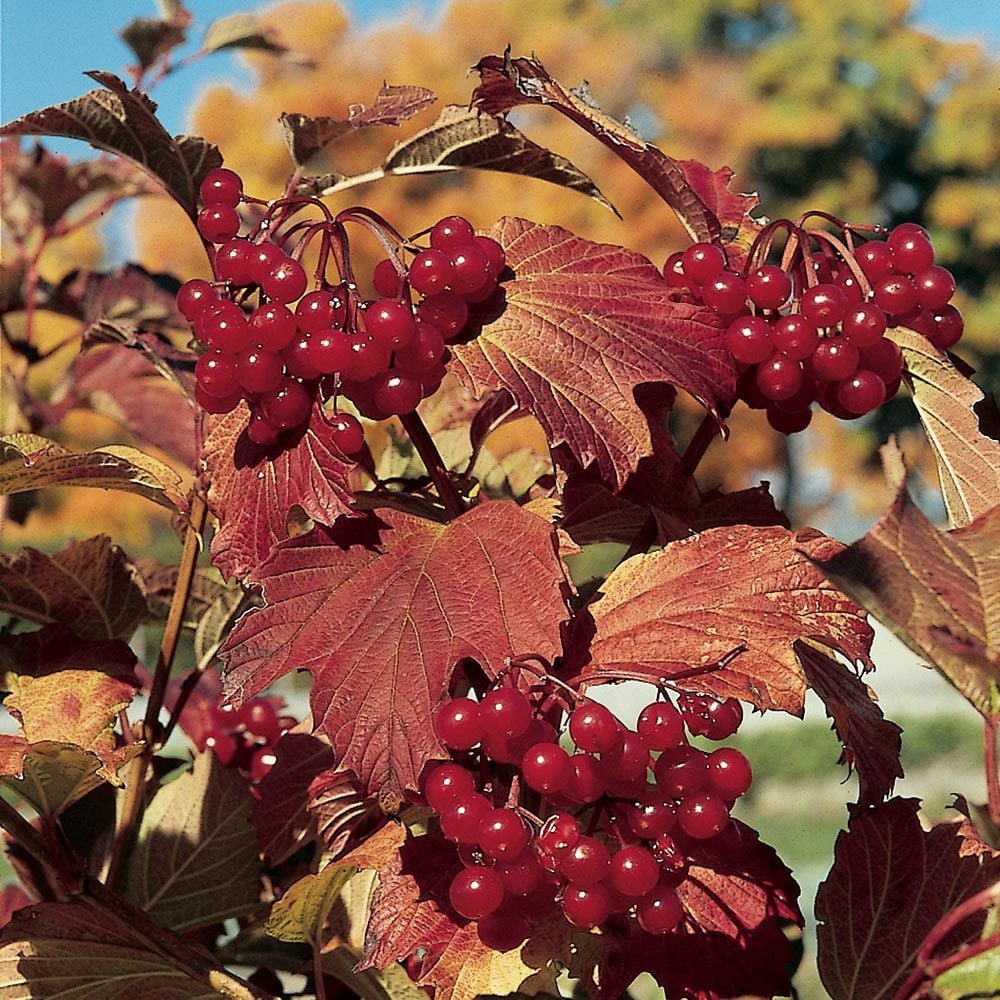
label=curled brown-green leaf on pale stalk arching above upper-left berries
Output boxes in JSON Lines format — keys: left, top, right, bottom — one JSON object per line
{"left": 298, "top": 104, "right": 617, "bottom": 214}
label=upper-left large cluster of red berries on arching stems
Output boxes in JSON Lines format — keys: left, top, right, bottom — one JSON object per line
{"left": 177, "top": 168, "right": 504, "bottom": 455}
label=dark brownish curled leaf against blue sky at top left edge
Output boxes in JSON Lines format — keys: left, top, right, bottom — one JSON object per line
{"left": 0, "top": 70, "right": 222, "bottom": 218}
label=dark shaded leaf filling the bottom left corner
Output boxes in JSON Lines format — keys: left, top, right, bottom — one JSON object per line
{"left": 0, "top": 896, "right": 267, "bottom": 1000}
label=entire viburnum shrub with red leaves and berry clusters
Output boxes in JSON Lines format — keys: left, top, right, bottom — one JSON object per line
{"left": 0, "top": 17, "right": 1000, "bottom": 1000}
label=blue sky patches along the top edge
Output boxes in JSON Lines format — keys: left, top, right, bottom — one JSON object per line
{"left": 0, "top": 0, "right": 1000, "bottom": 142}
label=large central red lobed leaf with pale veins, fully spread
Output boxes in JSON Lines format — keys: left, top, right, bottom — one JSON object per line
{"left": 220, "top": 502, "right": 567, "bottom": 793}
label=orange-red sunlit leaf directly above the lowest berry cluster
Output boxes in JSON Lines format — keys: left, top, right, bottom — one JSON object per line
{"left": 574, "top": 525, "right": 872, "bottom": 715}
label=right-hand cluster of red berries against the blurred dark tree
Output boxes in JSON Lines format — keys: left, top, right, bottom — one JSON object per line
{"left": 664, "top": 222, "right": 963, "bottom": 434}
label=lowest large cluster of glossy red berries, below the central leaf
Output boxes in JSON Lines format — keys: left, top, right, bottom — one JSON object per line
{"left": 423, "top": 686, "right": 752, "bottom": 950}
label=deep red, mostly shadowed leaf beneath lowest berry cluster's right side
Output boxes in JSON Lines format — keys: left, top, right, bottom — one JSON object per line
{"left": 571, "top": 822, "right": 803, "bottom": 1000}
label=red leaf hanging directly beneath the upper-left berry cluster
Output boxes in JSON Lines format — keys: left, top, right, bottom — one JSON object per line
{"left": 201, "top": 403, "right": 364, "bottom": 577}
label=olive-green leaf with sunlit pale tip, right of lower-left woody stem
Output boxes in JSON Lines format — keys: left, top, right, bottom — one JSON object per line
{"left": 124, "top": 753, "right": 260, "bottom": 930}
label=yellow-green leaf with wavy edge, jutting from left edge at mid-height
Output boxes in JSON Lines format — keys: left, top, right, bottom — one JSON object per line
{"left": 0, "top": 434, "right": 184, "bottom": 510}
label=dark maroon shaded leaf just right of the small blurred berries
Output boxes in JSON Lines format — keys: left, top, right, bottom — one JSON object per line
{"left": 253, "top": 733, "right": 334, "bottom": 864}
